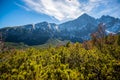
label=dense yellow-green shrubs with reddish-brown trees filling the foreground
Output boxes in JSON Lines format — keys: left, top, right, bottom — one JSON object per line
{"left": 0, "top": 34, "right": 120, "bottom": 80}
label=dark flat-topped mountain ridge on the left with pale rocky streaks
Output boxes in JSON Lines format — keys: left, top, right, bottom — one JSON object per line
{"left": 0, "top": 22, "right": 56, "bottom": 45}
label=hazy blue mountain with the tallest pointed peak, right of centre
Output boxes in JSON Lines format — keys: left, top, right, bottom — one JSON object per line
{"left": 59, "top": 14, "right": 97, "bottom": 41}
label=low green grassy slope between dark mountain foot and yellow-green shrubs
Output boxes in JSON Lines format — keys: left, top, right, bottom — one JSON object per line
{"left": 5, "top": 39, "right": 69, "bottom": 49}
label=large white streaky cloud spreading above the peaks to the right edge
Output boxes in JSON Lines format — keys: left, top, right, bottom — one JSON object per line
{"left": 23, "top": 0, "right": 120, "bottom": 21}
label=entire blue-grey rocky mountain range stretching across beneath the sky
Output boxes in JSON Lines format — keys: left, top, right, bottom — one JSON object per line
{"left": 0, "top": 14, "right": 120, "bottom": 45}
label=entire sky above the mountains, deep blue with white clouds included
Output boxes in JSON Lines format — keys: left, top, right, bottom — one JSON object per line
{"left": 0, "top": 0, "right": 120, "bottom": 27}
